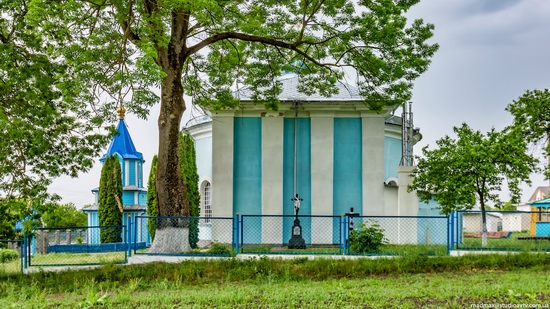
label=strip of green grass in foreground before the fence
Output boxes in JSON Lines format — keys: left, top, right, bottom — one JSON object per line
{"left": 0, "top": 253, "right": 550, "bottom": 308}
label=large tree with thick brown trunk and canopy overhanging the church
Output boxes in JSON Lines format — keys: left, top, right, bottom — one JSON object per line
{"left": 28, "top": 0, "right": 438, "bottom": 248}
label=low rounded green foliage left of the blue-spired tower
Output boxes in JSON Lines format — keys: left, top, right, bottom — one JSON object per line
{"left": 42, "top": 204, "right": 88, "bottom": 227}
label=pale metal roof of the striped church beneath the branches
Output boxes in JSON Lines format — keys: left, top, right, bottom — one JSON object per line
{"left": 235, "top": 74, "right": 363, "bottom": 102}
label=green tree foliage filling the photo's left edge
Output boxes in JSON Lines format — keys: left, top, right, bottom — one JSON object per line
{"left": 0, "top": 0, "right": 112, "bottom": 220}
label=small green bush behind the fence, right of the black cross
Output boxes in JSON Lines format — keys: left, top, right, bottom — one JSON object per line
{"left": 349, "top": 223, "right": 388, "bottom": 253}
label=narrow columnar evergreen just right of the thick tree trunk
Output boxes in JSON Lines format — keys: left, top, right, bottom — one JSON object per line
{"left": 178, "top": 133, "right": 200, "bottom": 248}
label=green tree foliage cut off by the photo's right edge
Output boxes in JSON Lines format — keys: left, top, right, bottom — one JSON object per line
{"left": 506, "top": 89, "right": 550, "bottom": 180}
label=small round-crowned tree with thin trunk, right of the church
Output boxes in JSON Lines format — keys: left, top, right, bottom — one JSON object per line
{"left": 409, "top": 124, "right": 538, "bottom": 246}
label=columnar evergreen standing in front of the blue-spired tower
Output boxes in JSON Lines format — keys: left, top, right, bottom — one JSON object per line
{"left": 98, "top": 155, "right": 122, "bottom": 243}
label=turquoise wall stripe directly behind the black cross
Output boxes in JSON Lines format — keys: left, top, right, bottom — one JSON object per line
{"left": 283, "top": 118, "right": 311, "bottom": 243}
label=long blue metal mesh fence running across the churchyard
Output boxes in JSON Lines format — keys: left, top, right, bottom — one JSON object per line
{"left": 16, "top": 211, "right": 550, "bottom": 267}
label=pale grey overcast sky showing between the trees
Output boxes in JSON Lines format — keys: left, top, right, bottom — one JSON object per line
{"left": 50, "top": 0, "right": 550, "bottom": 207}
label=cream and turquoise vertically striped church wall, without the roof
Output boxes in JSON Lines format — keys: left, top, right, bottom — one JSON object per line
{"left": 212, "top": 106, "right": 410, "bottom": 243}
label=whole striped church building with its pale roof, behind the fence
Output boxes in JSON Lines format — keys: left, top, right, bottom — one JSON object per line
{"left": 184, "top": 74, "right": 437, "bottom": 242}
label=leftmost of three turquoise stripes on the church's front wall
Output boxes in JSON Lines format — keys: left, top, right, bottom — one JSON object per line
{"left": 233, "top": 117, "right": 262, "bottom": 243}
